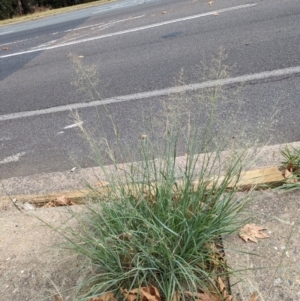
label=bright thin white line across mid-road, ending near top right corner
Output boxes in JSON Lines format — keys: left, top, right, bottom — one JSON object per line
{"left": 0, "top": 3, "right": 256, "bottom": 58}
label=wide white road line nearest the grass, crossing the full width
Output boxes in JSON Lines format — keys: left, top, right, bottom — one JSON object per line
{"left": 0, "top": 66, "right": 300, "bottom": 121}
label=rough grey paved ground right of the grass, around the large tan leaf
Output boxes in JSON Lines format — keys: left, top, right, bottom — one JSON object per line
{"left": 224, "top": 190, "right": 300, "bottom": 301}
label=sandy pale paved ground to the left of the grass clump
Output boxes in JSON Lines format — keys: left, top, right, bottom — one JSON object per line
{"left": 0, "top": 208, "right": 85, "bottom": 301}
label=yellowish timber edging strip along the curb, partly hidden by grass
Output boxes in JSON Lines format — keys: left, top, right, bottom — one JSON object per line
{"left": 0, "top": 166, "right": 285, "bottom": 206}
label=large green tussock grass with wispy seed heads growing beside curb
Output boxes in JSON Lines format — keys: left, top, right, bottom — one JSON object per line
{"left": 54, "top": 53, "right": 268, "bottom": 301}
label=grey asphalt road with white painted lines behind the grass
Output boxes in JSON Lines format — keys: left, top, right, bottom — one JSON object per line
{"left": 0, "top": 0, "right": 300, "bottom": 178}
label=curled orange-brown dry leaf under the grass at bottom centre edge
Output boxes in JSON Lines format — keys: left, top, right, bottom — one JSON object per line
{"left": 122, "top": 286, "right": 160, "bottom": 301}
